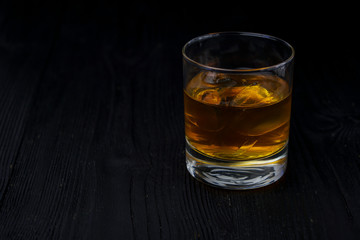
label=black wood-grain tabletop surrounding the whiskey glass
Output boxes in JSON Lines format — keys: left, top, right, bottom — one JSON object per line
{"left": 0, "top": 1, "right": 360, "bottom": 240}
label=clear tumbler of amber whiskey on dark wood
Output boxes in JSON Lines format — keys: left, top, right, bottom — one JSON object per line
{"left": 182, "top": 32, "right": 294, "bottom": 189}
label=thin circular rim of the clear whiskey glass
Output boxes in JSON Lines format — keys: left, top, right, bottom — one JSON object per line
{"left": 182, "top": 31, "right": 295, "bottom": 73}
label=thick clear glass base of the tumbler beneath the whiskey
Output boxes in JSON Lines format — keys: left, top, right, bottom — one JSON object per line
{"left": 186, "top": 143, "right": 288, "bottom": 190}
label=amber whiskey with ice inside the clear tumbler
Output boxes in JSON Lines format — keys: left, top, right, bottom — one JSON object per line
{"left": 184, "top": 72, "right": 291, "bottom": 160}
